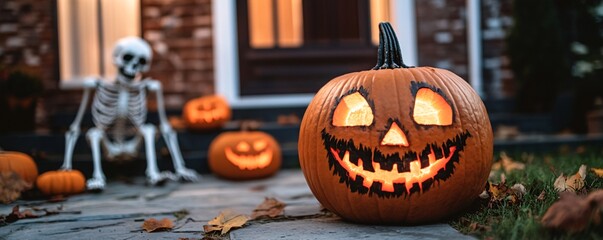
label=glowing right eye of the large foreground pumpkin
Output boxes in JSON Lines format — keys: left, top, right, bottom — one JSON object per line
{"left": 412, "top": 88, "right": 452, "bottom": 126}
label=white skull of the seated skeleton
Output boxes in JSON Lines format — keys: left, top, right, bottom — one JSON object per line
{"left": 113, "top": 37, "right": 153, "bottom": 80}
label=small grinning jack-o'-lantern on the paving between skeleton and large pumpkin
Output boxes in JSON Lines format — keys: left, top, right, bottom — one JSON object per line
{"left": 208, "top": 130, "right": 281, "bottom": 180}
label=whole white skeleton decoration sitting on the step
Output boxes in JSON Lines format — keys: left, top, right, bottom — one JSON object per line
{"left": 61, "top": 37, "right": 199, "bottom": 190}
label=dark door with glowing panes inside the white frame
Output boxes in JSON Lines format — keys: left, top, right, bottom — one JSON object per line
{"left": 237, "top": 0, "right": 390, "bottom": 95}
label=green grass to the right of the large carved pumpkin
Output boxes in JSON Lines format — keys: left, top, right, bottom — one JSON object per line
{"left": 450, "top": 147, "right": 603, "bottom": 239}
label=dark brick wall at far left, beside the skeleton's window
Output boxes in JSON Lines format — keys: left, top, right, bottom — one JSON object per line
{"left": 0, "top": 0, "right": 58, "bottom": 127}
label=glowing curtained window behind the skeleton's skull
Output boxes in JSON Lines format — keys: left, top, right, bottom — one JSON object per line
{"left": 57, "top": 0, "right": 140, "bottom": 88}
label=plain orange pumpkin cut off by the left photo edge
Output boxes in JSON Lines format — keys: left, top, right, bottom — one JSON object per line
{"left": 0, "top": 151, "right": 38, "bottom": 184}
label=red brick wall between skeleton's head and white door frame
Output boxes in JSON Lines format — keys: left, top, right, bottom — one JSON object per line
{"left": 141, "top": 0, "right": 214, "bottom": 108}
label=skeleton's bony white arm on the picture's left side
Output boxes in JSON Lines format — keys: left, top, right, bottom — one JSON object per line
{"left": 61, "top": 78, "right": 99, "bottom": 170}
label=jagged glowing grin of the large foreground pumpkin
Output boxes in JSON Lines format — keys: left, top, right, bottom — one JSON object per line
{"left": 322, "top": 129, "right": 471, "bottom": 197}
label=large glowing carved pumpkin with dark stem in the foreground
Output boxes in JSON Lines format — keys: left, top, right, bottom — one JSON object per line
{"left": 298, "top": 23, "right": 493, "bottom": 224}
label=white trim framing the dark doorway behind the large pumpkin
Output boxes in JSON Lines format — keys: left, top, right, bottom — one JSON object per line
{"left": 212, "top": 0, "right": 418, "bottom": 108}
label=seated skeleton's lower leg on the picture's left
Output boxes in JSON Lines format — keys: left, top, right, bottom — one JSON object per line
{"left": 86, "top": 127, "right": 105, "bottom": 190}
